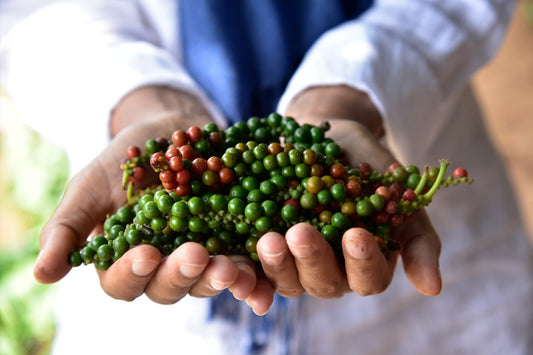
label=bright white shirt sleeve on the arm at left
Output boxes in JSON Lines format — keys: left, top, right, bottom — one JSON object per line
{"left": 1, "top": 0, "right": 223, "bottom": 175}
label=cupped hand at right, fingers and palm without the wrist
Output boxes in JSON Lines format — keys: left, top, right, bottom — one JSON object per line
{"left": 252, "top": 119, "right": 441, "bottom": 308}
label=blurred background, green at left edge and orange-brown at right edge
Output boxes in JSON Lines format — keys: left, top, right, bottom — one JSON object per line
{"left": 0, "top": 0, "right": 533, "bottom": 355}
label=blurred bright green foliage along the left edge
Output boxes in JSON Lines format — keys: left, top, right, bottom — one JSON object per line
{"left": 0, "top": 97, "right": 68, "bottom": 355}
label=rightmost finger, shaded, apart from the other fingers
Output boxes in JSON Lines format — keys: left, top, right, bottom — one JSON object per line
{"left": 394, "top": 211, "right": 442, "bottom": 296}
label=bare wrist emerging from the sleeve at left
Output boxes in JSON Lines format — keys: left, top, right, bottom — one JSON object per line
{"left": 110, "top": 86, "right": 212, "bottom": 136}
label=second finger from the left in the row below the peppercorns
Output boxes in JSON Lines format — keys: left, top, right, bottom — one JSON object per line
{"left": 145, "top": 242, "right": 209, "bottom": 304}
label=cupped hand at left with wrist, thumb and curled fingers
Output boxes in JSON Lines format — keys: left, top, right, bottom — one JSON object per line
{"left": 34, "top": 87, "right": 256, "bottom": 304}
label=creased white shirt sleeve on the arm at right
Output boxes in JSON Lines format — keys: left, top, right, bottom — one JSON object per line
{"left": 278, "top": 0, "right": 514, "bottom": 145}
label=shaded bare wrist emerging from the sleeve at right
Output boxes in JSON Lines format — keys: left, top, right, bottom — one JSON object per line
{"left": 284, "top": 85, "right": 383, "bottom": 138}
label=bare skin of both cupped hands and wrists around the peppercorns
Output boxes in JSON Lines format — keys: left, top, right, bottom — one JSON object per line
{"left": 34, "top": 86, "right": 441, "bottom": 315}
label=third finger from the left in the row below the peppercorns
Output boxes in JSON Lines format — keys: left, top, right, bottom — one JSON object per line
{"left": 189, "top": 255, "right": 239, "bottom": 297}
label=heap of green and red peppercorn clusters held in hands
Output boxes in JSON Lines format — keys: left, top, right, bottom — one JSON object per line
{"left": 70, "top": 113, "right": 472, "bottom": 269}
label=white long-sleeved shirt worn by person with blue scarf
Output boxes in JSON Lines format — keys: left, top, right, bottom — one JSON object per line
{"left": 0, "top": 0, "right": 533, "bottom": 355}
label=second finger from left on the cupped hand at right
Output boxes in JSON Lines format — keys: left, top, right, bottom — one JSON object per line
{"left": 285, "top": 223, "right": 348, "bottom": 298}
